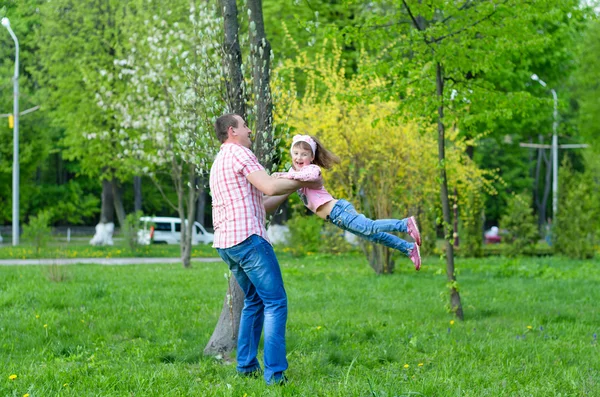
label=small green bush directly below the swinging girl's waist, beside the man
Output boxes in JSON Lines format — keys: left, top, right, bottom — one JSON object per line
{"left": 286, "top": 214, "right": 323, "bottom": 256}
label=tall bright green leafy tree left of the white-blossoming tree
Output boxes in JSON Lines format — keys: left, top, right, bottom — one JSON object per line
{"left": 36, "top": 0, "right": 136, "bottom": 229}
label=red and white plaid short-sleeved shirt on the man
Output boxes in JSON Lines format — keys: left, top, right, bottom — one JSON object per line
{"left": 210, "top": 143, "right": 269, "bottom": 248}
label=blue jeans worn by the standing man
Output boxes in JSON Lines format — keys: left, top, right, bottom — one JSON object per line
{"left": 217, "top": 234, "right": 288, "bottom": 384}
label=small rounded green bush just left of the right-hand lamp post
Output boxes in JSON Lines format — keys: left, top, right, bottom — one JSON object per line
{"left": 500, "top": 193, "right": 539, "bottom": 256}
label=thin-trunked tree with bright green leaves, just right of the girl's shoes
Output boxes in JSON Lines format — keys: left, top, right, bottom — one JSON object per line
{"left": 342, "top": 0, "right": 577, "bottom": 319}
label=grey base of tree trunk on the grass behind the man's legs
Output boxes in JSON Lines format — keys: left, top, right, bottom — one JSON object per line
{"left": 204, "top": 276, "right": 244, "bottom": 359}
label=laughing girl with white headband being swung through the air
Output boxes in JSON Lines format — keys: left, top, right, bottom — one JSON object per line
{"left": 274, "top": 135, "right": 421, "bottom": 270}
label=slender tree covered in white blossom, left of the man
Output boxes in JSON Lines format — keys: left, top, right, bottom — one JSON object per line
{"left": 97, "top": 3, "right": 225, "bottom": 267}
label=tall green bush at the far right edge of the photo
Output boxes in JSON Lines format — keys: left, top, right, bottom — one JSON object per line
{"left": 552, "top": 161, "right": 600, "bottom": 259}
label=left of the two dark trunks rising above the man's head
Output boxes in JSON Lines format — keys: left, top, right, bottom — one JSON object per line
{"left": 220, "top": 0, "right": 246, "bottom": 120}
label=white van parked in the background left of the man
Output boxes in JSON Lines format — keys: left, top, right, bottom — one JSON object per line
{"left": 138, "top": 216, "right": 214, "bottom": 245}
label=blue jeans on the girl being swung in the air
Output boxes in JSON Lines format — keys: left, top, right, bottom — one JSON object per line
{"left": 329, "top": 200, "right": 415, "bottom": 256}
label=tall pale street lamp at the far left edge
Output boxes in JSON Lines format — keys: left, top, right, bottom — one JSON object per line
{"left": 2, "top": 18, "right": 19, "bottom": 246}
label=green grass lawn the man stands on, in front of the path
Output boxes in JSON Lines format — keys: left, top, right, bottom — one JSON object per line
{"left": 0, "top": 255, "right": 600, "bottom": 397}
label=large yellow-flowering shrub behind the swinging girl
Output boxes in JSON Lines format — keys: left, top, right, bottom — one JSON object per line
{"left": 277, "top": 43, "right": 489, "bottom": 273}
